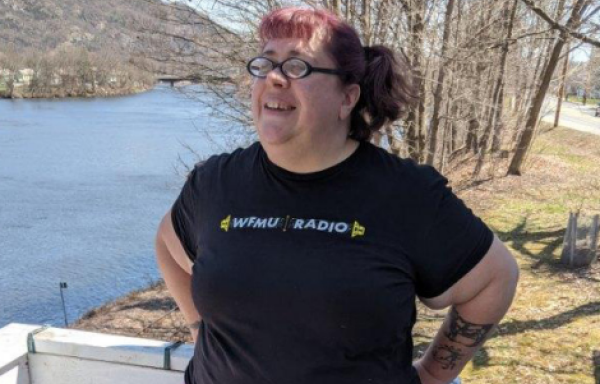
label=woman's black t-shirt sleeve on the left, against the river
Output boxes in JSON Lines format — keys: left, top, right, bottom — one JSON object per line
{"left": 171, "top": 163, "right": 203, "bottom": 261}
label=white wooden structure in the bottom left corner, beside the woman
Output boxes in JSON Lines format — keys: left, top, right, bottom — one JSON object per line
{"left": 0, "top": 323, "right": 193, "bottom": 384}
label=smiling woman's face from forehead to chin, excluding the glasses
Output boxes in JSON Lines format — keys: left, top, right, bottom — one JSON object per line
{"left": 252, "top": 38, "right": 357, "bottom": 148}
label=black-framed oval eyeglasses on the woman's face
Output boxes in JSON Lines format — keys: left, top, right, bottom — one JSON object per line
{"left": 246, "top": 56, "right": 342, "bottom": 80}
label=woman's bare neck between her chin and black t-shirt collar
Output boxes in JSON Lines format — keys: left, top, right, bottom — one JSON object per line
{"left": 262, "top": 135, "right": 359, "bottom": 173}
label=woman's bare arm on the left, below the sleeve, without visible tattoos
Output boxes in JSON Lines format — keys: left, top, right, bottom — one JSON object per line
{"left": 156, "top": 238, "right": 200, "bottom": 342}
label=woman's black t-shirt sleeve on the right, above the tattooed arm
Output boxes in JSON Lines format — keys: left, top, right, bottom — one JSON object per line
{"left": 413, "top": 166, "right": 494, "bottom": 298}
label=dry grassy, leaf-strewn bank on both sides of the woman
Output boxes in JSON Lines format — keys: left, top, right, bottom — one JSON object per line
{"left": 73, "top": 124, "right": 600, "bottom": 384}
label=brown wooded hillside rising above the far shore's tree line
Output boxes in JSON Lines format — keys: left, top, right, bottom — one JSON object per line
{"left": 0, "top": 0, "right": 228, "bottom": 75}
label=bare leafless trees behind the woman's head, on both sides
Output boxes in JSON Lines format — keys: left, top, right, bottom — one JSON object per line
{"left": 75, "top": 0, "right": 600, "bottom": 178}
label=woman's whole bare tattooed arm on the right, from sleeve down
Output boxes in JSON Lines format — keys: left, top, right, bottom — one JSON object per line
{"left": 414, "top": 236, "right": 519, "bottom": 384}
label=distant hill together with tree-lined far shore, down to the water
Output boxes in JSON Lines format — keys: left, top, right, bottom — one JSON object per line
{"left": 0, "top": 0, "right": 252, "bottom": 97}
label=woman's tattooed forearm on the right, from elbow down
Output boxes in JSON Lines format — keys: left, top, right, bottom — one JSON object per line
{"left": 415, "top": 280, "right": 516, "bottom": 384}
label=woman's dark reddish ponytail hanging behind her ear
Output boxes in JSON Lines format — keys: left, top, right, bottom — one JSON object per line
{"left": 350, "top": 45, "right": 415, "bottom": 141}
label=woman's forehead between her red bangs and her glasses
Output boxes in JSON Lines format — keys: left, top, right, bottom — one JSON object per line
{"left": 262, "top": 38, "right": 329, "bottom": 62}
